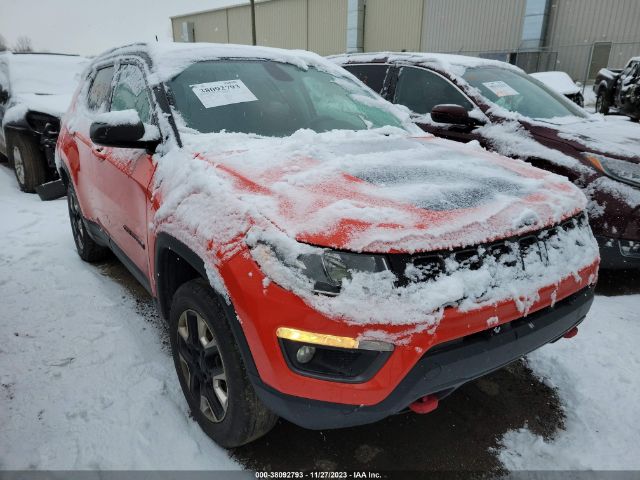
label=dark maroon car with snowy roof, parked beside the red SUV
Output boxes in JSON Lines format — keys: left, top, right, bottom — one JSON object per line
{"left": 330, "top": 52, "right": 640, "bottom": 269}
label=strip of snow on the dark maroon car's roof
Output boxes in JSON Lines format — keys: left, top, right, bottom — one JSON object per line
{"left": 327, "top": 52, "right": 522, "bottom": 76}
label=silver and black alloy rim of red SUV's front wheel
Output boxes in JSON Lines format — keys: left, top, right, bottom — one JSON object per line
{"left": 177, "top": 310, "right": 229, "bottom": 423}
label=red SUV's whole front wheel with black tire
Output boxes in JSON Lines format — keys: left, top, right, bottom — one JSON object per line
{"left": 169, "top": 279, "right": 278, "bottom": 448}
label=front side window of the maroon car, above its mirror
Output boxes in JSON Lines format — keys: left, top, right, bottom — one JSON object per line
{"left": 393, "top": 67, "right": 473, "bottom": 114}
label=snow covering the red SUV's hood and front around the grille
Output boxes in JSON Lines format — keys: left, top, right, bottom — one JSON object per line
{"left": 154, "top": 127, "right": 598, "bottom": 329}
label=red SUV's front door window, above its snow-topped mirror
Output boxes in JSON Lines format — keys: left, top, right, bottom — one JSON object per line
{"left": 111, "top": 64, "right": 153, "bottom": 123}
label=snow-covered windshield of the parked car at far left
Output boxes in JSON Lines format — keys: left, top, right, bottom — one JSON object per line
{"left": 9, "top": 53, "right": 88, "bottom": 95}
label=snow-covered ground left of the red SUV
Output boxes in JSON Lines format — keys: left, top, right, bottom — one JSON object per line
{"left": 0, "top": 165, "right": 240, "bottom": 470}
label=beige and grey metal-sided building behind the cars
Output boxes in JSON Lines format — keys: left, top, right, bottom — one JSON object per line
{"left": 172, "top": 0, "right": 640, "bottom": 80}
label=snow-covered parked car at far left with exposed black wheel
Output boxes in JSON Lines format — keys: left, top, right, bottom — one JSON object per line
{"left": 0, "top": 52, "right": 88, "bottom": 192}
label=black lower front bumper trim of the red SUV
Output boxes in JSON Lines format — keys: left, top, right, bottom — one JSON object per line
{"left": 251, "top": 288, "right": 593, "bottom": 430}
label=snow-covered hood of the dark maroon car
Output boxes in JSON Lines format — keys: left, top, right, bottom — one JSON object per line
{"left": 521, "top": 115, "right": 640, "bottom": 163}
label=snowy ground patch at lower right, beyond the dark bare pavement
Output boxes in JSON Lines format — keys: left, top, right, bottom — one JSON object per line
{"left": 498, "top": 295, "right": 640, "bottom": 470}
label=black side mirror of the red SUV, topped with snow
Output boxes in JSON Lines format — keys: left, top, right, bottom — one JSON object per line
{"left": 89, "top": 110, "right": 160, "bottom": 152}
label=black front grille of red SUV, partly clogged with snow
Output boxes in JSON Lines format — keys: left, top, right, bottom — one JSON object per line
{"left": 388, "top": 214, "right": 588, "bottom": 285}
